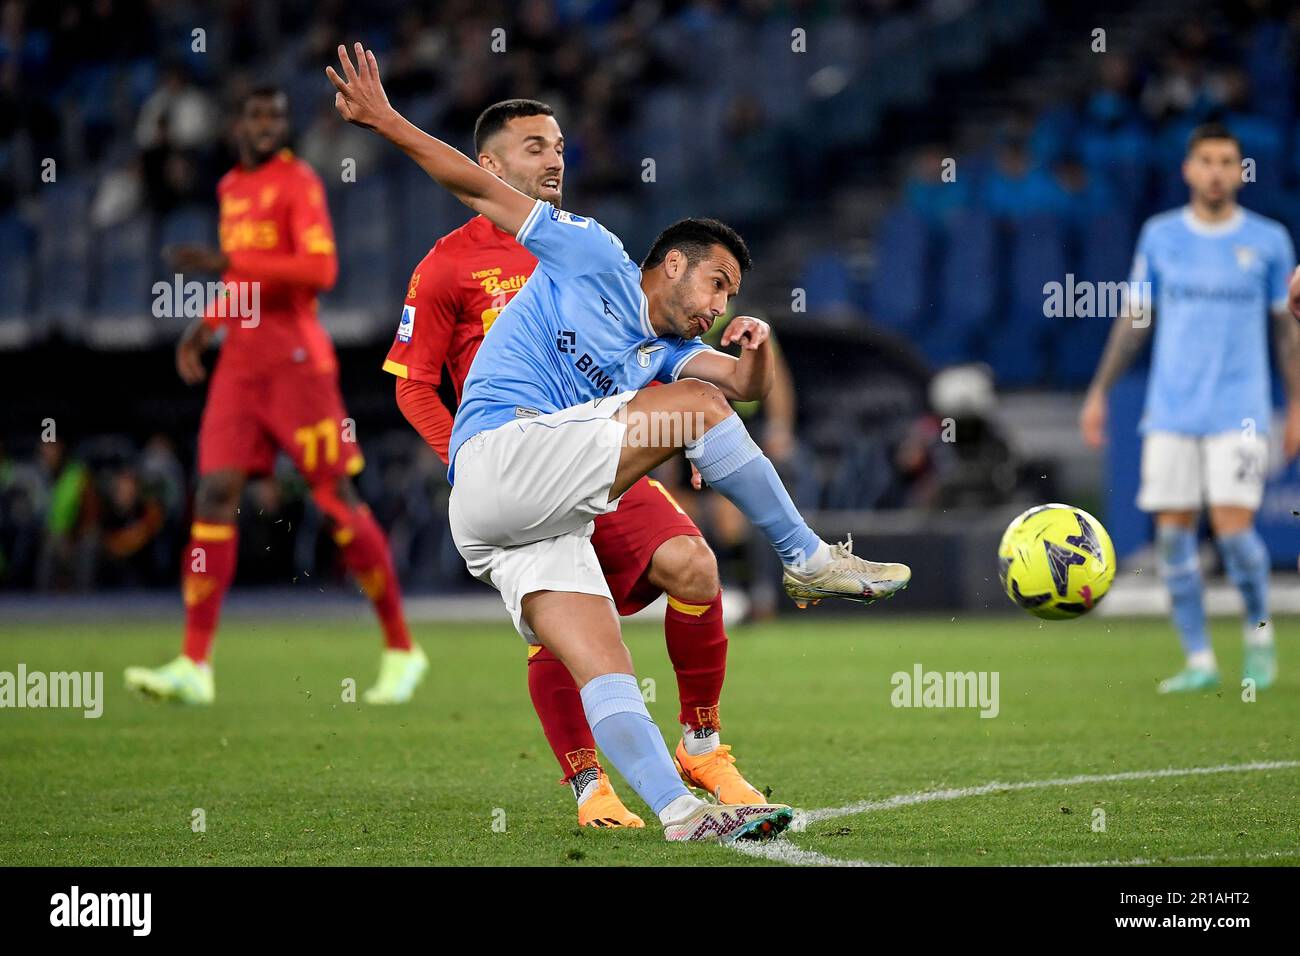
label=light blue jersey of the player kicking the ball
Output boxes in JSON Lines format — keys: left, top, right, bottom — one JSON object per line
{"left": 447, "top": 200, "right": 709, "bottom": 481}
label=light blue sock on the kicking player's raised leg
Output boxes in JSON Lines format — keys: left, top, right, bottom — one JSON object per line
{"left": 686, "top": 415, "right": 822, "bottom": 564}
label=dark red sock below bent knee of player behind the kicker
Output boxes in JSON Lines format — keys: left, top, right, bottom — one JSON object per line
{"left": 663, "top": 592, "right": 727, "bottom": 731}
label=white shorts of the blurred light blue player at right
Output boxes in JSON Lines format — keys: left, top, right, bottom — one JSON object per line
{"left": 1138, "top": 432, "right": 1269, "bottom": 511}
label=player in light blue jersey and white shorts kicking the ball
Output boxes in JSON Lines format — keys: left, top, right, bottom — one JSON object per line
{"left": 328, "top": 44, "right": 911, "bottom": 840}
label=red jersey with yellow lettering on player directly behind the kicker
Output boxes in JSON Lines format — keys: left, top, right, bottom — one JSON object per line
{"left": 384, "top": 216, "right": 537, "bottom": 400}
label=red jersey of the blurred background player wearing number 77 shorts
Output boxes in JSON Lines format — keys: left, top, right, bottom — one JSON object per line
{"left": 208, "top": 150, "right": 338, "bottom": 372}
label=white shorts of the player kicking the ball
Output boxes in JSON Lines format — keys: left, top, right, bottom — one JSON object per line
{"left": 447, "top": 392, "right": 636, "bottom": 644}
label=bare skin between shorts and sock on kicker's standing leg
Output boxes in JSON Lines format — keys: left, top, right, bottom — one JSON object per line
{"left": 523, "top": 591, "right": 632, "bottom": 688}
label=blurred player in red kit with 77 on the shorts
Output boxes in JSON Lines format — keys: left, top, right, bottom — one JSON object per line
{"left": 126, "top": 88, "right": 428, "bottom": 704}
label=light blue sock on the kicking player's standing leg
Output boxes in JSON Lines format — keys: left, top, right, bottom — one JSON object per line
{"left": 581, "top": 674, "right": 690, "bottom": 813}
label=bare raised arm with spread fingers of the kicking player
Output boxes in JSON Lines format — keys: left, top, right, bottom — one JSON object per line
{"left": 325, "top": 43, "right": 534, "bottom": 235}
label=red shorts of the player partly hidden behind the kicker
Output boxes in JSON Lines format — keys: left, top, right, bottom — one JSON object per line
{"left": 592, "top": 479, "right": 702, "bottom": 614}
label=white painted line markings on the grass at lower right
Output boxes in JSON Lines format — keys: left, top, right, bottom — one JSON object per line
{"left": 732, "top": 760, "right": 1300, "bottom": 866}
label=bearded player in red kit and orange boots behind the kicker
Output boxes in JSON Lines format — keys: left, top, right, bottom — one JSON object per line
{"left": 384, "top": 100, "right": 766, "bottom": 827}
